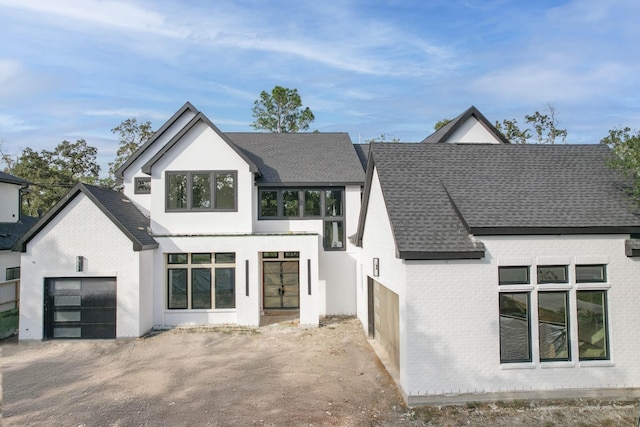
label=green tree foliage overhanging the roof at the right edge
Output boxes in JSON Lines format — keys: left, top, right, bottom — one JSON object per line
{"left": 600, "top": 127, "right": 640, "bottom": 204}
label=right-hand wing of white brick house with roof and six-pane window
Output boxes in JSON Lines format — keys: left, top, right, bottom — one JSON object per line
{"left": 355, "top": 129, "right": 640, "bottom": 404}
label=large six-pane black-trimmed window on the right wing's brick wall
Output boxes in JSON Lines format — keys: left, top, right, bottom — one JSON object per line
{"left": 498, "top": 264, "right": 610, "bottom": 363}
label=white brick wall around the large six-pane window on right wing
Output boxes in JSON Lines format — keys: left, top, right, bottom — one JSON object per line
{"left": 401, "top": 235, "right": 640, "bottom": 395}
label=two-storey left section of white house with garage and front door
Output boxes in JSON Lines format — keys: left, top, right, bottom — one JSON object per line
{"left": 15, "top": 103, "right": 364, "bottom": 339}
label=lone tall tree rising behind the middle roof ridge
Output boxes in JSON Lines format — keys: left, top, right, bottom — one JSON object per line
{"left": 251, "top": 86, "right": 315, "bottom": 133}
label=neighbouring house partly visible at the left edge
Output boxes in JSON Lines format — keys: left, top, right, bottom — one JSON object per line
{"left": 0, "top": 172, "right": 35, "bottom": 338}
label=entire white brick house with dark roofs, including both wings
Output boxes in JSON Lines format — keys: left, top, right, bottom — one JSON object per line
{"left": 14, "top": 103, "right": 640, "bottom": 404}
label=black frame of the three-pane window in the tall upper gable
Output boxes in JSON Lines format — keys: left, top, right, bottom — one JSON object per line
{"left": 164, "top": 170, "right": 238, "bottom": 212}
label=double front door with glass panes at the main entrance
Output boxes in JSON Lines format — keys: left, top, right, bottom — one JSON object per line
{"left": 262, "top": 260, "right": 300, "bottom": 310}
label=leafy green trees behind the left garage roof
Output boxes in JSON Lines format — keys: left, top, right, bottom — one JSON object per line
{"left": 6, "top": 139, "right": 100, "bottom": 216}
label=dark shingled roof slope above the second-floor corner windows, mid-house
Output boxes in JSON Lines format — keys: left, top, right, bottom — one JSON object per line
{"left": 225, "top": 132, "right": 364, "bottom": 185}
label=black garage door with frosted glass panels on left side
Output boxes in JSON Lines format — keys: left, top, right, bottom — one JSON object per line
{"left": 44, "top": 277, "right": 116, "bottom": 339}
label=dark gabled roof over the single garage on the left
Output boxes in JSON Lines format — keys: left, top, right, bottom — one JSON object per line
{"left": 13, "top": 184, "right": 158, "bottom": 252}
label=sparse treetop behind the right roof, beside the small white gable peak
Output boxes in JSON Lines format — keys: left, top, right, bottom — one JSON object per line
{"left": 495, "top": 104, "right": 567, "bottom": 144}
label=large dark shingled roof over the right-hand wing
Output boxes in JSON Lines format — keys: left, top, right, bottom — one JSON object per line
{"left": 357, "top": 144, "right": 640, "bottom": 259}
